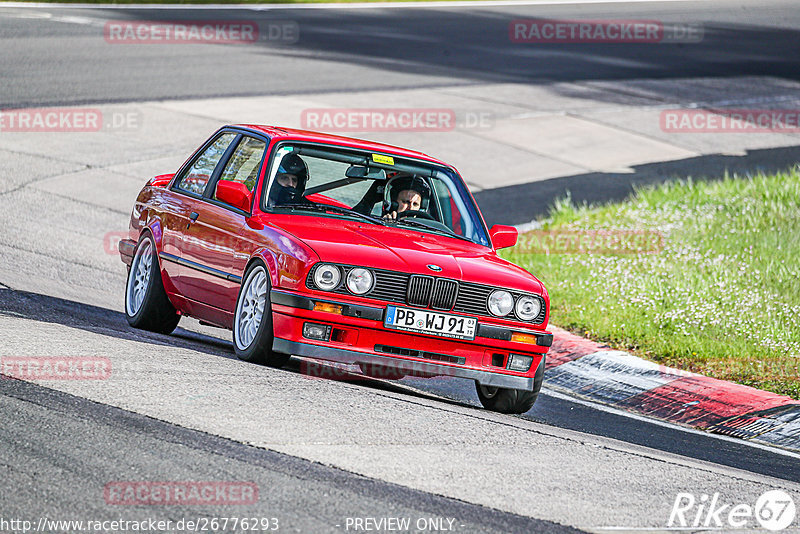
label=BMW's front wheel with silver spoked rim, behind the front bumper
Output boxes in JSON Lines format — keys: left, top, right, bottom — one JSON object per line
{"left": 233, "top": 261, "right": 290, "bottom": 367}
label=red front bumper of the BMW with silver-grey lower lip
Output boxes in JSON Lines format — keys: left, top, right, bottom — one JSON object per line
{"left": 270, "top": 290, "right": 552, "bottom": 391}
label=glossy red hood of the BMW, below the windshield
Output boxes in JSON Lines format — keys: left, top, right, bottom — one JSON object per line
{"left": 262, "top": 214, "right": 543, "bottom": 294}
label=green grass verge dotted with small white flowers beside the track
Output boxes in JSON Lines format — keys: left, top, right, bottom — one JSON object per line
{"left": 503, "top": 168, "right": 800, "bottom": 399}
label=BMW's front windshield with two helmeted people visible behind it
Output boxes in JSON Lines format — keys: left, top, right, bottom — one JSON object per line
{"left": 263, "top": 144, "right": 490, "bottom": 246}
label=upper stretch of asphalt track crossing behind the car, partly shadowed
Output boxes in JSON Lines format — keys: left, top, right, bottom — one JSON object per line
{"left": 0, "top": 0, "right": 800, "bottom": 108}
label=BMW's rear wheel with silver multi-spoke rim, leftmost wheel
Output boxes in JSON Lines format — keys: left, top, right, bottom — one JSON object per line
{"left": 125, "top": 234, "right": 181, "bottom": 334}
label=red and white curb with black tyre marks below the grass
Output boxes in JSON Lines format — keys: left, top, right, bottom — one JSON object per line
{"left": 545, "top": 325, "right": 800, "bottom": 451}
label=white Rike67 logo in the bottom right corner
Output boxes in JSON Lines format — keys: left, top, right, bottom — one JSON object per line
{"left": 667, "top": 490, "right": 796, "bottom": 531}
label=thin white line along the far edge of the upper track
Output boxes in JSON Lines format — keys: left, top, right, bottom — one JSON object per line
{"left": 0, "top": 0, "right": 697, "bottom": 11}
